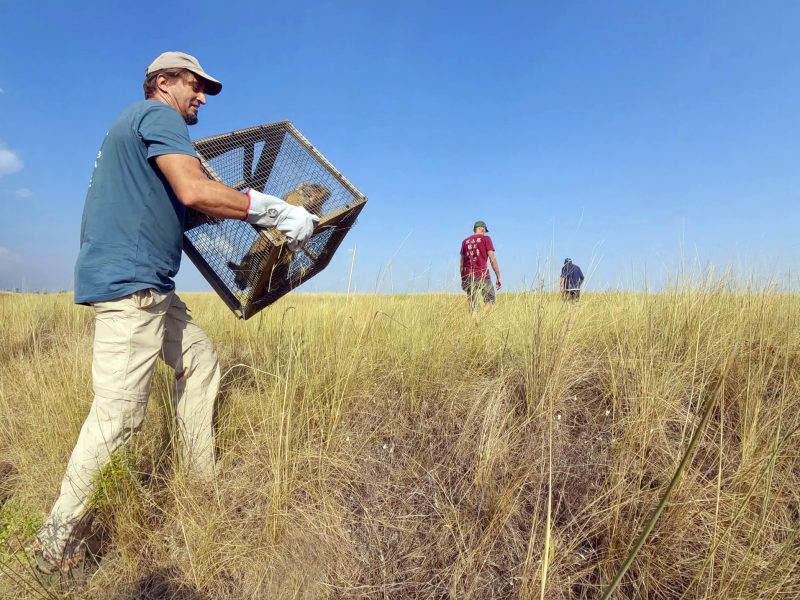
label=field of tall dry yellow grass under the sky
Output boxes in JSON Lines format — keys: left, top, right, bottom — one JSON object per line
{"left": 0, "top": 285, "right": 800, "bottom": 600}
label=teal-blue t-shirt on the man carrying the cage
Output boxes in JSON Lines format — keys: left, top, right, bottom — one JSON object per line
{"left": 75, "top": 100, "right": 197, "bottom": 304}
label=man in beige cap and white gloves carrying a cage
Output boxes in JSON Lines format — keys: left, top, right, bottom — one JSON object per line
{"left": 32, "top": 52, "right": 317, "bottom": 578}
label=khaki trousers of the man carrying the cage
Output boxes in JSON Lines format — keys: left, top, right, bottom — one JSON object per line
{"left": 38, "top": 289, "right": 219, "bottom": 558}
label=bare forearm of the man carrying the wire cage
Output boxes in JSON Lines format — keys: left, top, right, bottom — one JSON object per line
{"left": 155, "top": 154, "right": 249, "bottom": 219}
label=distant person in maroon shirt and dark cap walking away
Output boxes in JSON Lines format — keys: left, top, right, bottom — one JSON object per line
{"left": 459, "top": 221, "right": 503, "bottom": 314}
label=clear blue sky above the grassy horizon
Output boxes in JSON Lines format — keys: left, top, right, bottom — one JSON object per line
{"left": 0, "top": 0, "right": 800, "bottom": 292}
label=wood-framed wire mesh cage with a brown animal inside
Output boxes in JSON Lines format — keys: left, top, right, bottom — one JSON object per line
{"left": 183, "top": 121, "right": 367, "bottom": 319}
